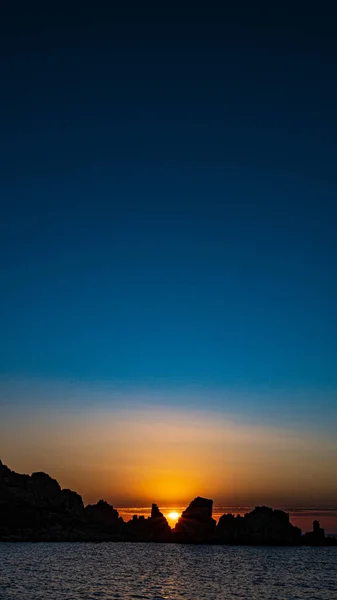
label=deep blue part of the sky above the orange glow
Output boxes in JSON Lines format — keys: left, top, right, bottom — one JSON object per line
{"left": 0, "top": 7, "right": 337, "bottom": 458}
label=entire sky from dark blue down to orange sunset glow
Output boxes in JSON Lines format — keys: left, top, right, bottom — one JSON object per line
{"left": 0, "top": 3, "right": 337, "bottom": 520}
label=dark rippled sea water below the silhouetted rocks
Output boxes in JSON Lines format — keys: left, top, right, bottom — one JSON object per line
{"left": 0, "top": 543, "right": 337, "bottom": 600}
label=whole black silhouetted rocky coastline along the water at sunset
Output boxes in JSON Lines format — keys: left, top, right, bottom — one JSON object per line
{"left": 0, "top": 461, "right": 337, "bottom": 546}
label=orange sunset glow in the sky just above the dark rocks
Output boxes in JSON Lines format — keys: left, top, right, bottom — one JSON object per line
{"left": 0, "top": 406, "right": 337, "bottom": 508}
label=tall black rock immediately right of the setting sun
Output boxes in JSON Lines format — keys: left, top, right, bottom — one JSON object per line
{"left": 174, "top": 496, "right": 216, "bottom": 542}
